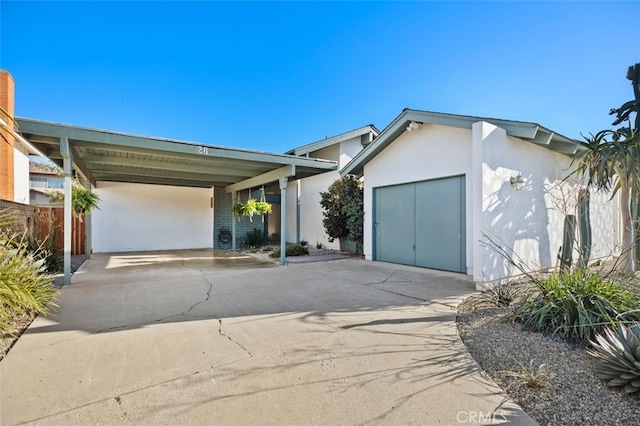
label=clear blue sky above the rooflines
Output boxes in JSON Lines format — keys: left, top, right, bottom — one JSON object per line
{"left": 0, "top": 0, "right": 640, "bottom": 152}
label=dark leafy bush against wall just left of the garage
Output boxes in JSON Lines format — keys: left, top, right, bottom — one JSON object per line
{"left": 320, "top": 175, "right": 364, "bottom": 244}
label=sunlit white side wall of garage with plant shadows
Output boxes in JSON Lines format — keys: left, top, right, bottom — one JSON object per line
{"left": 471, "top": 122, "right": 614, "bottom": 282}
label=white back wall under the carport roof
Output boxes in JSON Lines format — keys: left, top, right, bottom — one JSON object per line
{"left": 92, "top": 182, "right": 213, "bottom": 253}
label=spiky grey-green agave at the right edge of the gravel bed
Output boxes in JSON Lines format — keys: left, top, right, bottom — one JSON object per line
{"left": 587, "top": 323, "right": 640, "bottom": 394}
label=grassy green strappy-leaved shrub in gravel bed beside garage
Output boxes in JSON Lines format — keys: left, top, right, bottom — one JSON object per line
{"left": 515, "top": 269, "right": 640, "bottom": 344}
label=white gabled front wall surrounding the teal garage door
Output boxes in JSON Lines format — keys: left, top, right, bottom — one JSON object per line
{"left": 364, "top": 124, "right": 472, "bottom": 264}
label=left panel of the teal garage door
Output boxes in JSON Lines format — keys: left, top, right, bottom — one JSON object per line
{"left": 375, "top": 185, "right": 415, "bottom": 263}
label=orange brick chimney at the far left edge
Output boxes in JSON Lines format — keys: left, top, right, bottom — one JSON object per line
{"left": 0, "top": 70, "right": 15, "bottom": 201}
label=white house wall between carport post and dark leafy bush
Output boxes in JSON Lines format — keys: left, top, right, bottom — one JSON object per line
{"left": 287, "top": 136, "right": 362, "bottom": 250}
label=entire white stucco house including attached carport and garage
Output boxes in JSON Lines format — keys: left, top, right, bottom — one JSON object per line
{"left": 5, "top": 95, "right": 620, "bottom": 288}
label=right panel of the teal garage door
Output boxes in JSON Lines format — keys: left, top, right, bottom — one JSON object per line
{"left": 416, "top": 177, "right": 462, "bottom": 271}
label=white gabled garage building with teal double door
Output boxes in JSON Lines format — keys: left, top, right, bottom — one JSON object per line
{"left": 340, "top": 109, "right": 619, "bottom": 286}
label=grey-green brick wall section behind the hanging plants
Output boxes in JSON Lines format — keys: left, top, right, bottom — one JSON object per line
{"left": 213, "top": 187, "right": 266, "bottom": 250}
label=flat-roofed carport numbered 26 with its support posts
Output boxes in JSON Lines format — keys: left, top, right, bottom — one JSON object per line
{"left": 16, "top": 118, "right": 337, "bottom": 284}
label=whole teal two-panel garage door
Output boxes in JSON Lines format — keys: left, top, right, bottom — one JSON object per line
{"left": 373, "top": 176, "right": 466, "bottom": 272}
